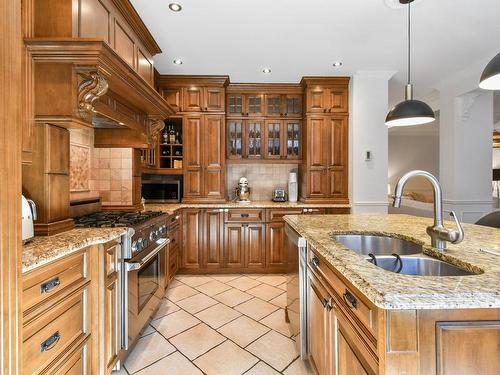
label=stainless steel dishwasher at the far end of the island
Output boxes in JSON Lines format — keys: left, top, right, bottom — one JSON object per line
{"left": 285, "top": 224, "right": 309, "bottom": 360}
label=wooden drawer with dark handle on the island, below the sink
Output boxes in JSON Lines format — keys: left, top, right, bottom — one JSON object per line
{"left": 307, "top": 248, "right": 377, "bottom": 335}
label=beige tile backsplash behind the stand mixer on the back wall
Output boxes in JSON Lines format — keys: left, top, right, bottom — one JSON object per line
{"left": 226, "top": 164, "right": 298, "bottom": 200}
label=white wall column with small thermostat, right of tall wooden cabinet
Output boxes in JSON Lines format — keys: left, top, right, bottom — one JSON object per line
{"left": 349, "top": 71, "right": 393, "bottom": 213}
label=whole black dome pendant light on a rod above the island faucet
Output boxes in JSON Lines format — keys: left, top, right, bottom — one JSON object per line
{"left": 385, "top": 0, "right": 435, "bottom": 127}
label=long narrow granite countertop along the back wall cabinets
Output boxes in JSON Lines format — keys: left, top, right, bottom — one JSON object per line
{"left": 146, "top": 201, "right": 351, "bottom": 214}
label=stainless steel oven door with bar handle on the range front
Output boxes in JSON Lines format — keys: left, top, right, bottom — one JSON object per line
{"left": 125, "top": 238, "right": 170, "bottom": 346}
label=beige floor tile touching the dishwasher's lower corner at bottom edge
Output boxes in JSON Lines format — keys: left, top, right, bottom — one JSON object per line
{"left": 246, "top": 331, "right": 298, "bottom": 371}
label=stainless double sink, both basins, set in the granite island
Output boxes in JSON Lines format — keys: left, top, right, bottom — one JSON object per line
{"left": 332, "top": 234, "right": 475, "bottom": 276}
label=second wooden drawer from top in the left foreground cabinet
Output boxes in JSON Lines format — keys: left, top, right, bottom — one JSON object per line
{"left": 22, "top": 288, "right": 89, "bottom": 374}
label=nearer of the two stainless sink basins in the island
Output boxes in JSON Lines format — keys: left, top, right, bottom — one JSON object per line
{"left": 367, "top": 255, "right": 475, "bottom": 276}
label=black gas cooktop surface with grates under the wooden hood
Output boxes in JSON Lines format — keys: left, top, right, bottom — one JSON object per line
{"left": 75, "top": 211, "right": 163, "bottom": 228}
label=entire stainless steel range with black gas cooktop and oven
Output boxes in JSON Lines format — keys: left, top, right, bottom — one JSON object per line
{"left": 75, "top": 211, "right": 170, "bottom": 360}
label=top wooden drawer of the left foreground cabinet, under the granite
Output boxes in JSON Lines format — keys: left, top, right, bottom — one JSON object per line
{"left": 23, "top": 248, "right": 88, "bottom": 311}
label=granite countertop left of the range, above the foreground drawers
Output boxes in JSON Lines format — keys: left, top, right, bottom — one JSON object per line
{"left": 22, "top": 228, "right": 126, "bottom": 273}
